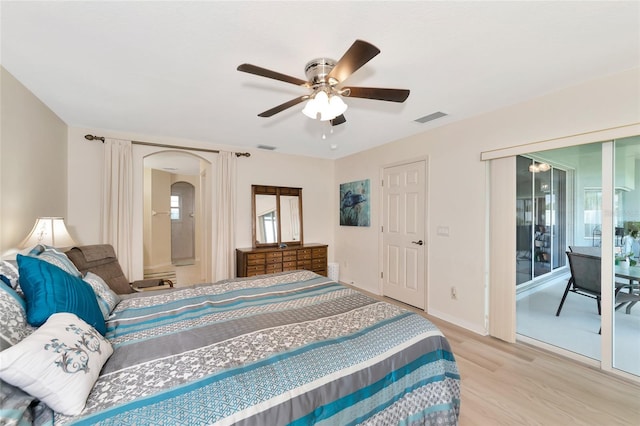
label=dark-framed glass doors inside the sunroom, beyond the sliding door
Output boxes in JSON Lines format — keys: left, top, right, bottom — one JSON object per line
{"left": 516, "top": 156, "right": 567, "bottom": 285}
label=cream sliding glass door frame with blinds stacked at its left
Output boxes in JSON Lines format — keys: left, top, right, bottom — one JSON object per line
{"left": 480, "top": 123, "right": 640, "bottom": 383}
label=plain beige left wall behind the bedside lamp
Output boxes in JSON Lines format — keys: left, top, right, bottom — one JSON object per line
{"left": 0, "top": 67, "right": 68, "bottom": 256}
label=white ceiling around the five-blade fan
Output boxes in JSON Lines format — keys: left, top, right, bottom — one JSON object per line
{"left": 0, "top": 0, "right": 640, "bottom": 158}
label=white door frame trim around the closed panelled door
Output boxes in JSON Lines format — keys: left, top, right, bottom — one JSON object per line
{"left": 371, "top": 155, "right": 431, "bottom": 313}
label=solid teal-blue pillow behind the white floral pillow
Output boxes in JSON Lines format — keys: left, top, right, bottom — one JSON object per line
{"left": 18, "top": 254, "right": 107, "bottom": 335}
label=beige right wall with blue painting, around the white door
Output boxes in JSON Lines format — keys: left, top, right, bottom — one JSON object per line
{"left": 334, "top": 69, "right": 640, "bottom": 333}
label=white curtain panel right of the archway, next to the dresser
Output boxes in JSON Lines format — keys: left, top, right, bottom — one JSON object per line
{"left": 213, "top": 151, "right": 237, "bottom": 282}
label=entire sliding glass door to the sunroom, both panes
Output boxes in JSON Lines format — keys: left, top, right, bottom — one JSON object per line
{"left": 515, "top": 140, "right": 640, "bottom": 376}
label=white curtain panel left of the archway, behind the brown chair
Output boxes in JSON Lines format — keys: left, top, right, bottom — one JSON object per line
{"left": 102, "top": 139, "right": 133, "bottom": 280}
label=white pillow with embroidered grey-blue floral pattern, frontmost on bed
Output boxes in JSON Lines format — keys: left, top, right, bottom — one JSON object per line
{"left": 0, "top": 312, "right": 113, "bottom": 416}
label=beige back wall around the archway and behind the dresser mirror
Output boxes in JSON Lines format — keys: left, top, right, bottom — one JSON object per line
{"left": 68, "top": 127, "right": 337, "bottom": 280}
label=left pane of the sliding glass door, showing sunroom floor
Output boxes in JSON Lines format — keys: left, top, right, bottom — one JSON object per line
{"left": 516, "top": 144, "right": 602, "bottom": 360}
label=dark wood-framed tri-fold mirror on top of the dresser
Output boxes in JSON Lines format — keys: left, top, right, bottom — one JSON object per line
{"left": 251, "top": 185, "right": 302, "bottom": 247}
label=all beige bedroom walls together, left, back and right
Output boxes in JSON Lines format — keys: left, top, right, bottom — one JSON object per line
{"left": 0, "top": 63, "right": 640, "bottom": 333}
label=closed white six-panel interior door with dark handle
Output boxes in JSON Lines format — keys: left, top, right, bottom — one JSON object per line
{"left": 382, "top": 160, "right": 426, "bottom": 309}
